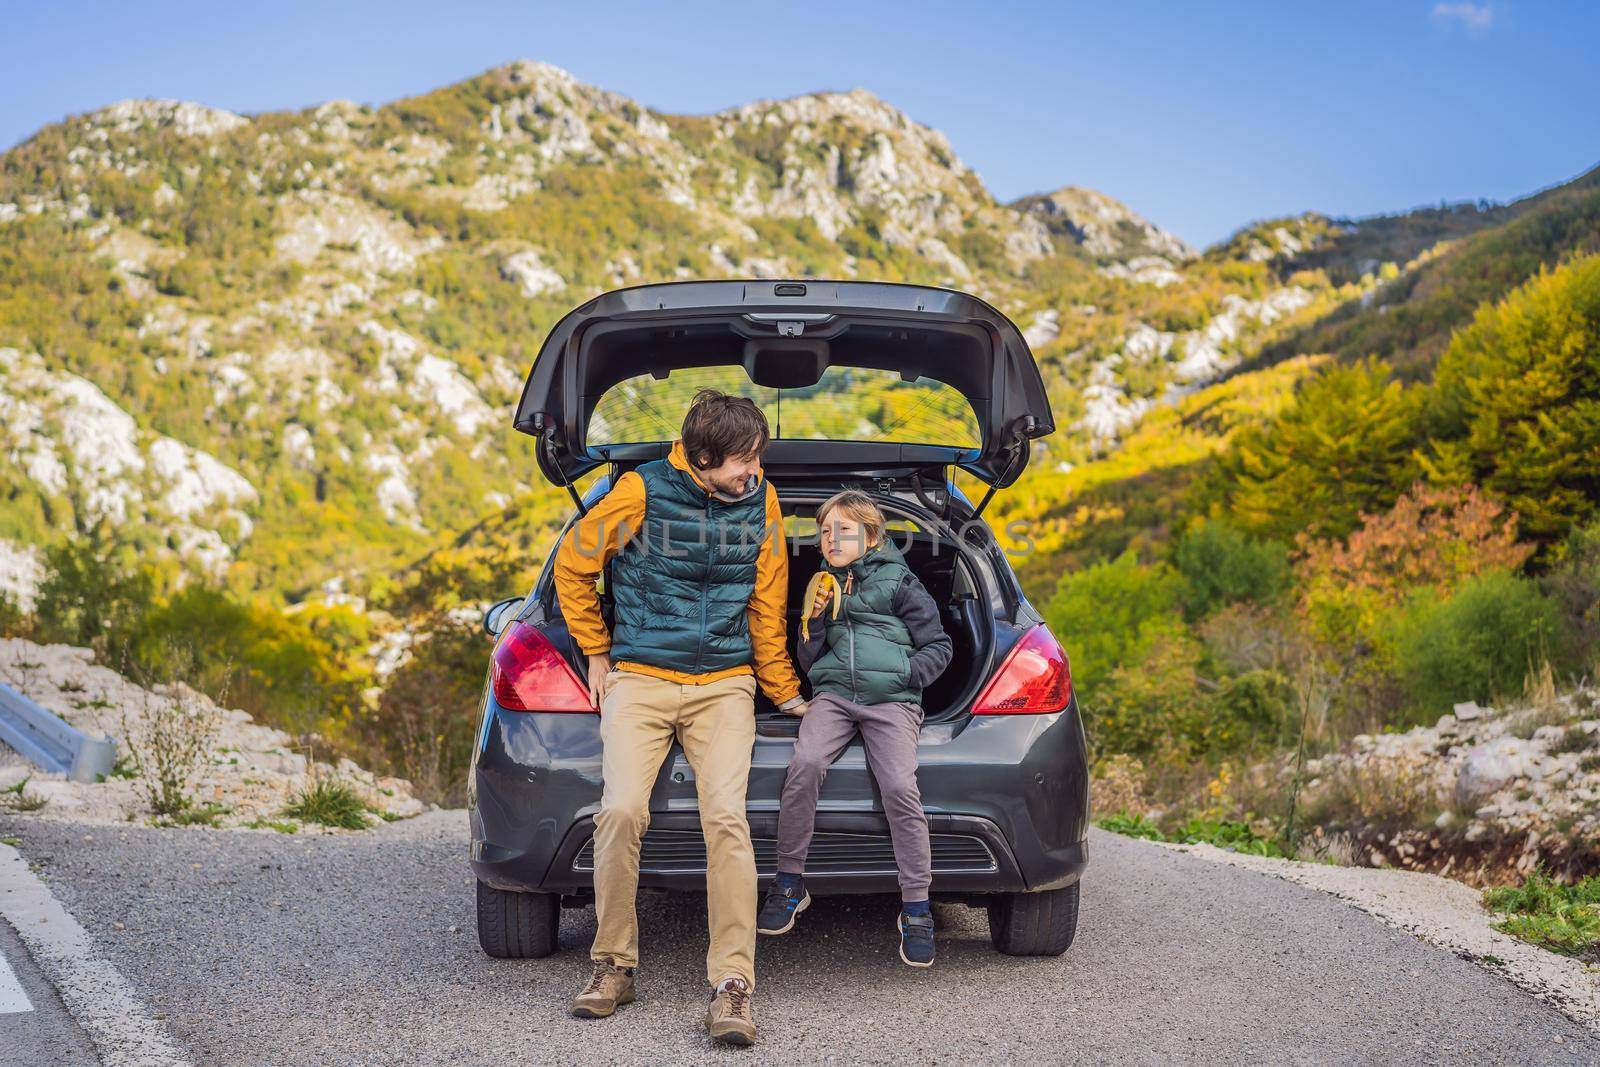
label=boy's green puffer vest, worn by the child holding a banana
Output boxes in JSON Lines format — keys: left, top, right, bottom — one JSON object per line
{"left": 803, "top": 537, "right": 922, "bottom": 704}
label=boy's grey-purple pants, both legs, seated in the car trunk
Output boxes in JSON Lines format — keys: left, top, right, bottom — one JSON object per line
{"left": 778, "top": 693, "right": 933, "bottom": 901}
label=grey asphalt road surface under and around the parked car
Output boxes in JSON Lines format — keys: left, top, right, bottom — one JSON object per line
{"left": 0, "top": 811, "right": 1600, "bottom": 1064}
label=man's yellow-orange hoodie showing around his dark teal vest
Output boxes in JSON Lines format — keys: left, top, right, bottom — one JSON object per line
{"left": 555, "top": 442, "right": 800, "bottom": 704}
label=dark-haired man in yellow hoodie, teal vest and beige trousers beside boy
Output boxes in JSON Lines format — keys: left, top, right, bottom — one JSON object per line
{"left": 555, "top": 389, "right": 802, "bottom": 1045}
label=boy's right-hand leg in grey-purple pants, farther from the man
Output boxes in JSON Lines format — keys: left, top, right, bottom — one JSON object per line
{"left": 856, "top": 701, "right": 933, "bottom": 902}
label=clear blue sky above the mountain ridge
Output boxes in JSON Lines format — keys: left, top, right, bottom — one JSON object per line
{"left": 0, "top": 0, "right": 1600, "bottom": 243}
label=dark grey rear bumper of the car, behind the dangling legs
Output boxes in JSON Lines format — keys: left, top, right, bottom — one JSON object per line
{"left": 469, "top": 701, "right": 1088, "bottom": 896}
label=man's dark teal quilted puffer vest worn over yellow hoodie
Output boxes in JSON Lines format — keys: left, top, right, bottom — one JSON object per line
{"left": 611, "top": 459, "right": 766, "bottom": 673}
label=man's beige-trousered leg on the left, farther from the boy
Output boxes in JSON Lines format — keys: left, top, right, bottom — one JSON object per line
{"left": 589, "top": 670, "right": 685, "bottom": 968}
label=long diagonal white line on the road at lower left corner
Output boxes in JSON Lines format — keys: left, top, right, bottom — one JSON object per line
{"left": 0, "top": 845, "right": 189, "bottom": 1067}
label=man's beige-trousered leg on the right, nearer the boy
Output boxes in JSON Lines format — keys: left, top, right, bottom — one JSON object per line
{"left": 678, "top": 675, "right": 755, "bottom": 989}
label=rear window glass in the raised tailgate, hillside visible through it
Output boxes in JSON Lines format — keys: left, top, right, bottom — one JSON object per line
{"left": 586, "top": 366, "right": 982, "bottom": 448}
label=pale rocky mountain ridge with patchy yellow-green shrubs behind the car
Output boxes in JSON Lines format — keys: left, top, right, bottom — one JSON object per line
{"left": 0, "top": 62, "right": 1548, "bottom": 601}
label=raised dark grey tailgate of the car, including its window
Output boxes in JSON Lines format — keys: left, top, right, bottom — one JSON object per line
{"left": 515, "top": 280, "right": 1054, "bottom": 498}
